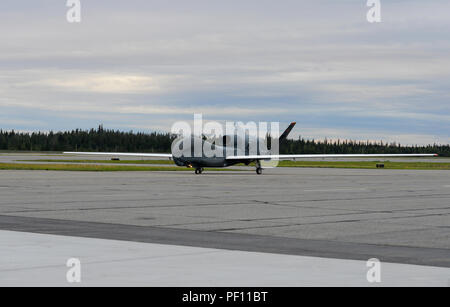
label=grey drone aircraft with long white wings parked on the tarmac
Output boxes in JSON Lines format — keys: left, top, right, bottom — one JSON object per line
{"left": 64, "top": 122, "right": 437, "bottom": 175}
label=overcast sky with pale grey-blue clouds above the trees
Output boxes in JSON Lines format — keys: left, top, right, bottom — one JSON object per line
{"left": 0, "top": 0, "right": 450, "bottom": 144}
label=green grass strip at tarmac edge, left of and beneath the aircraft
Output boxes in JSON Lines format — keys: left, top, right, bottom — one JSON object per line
{"left": 0, "top": 163, "right": 230, "bottom": 172}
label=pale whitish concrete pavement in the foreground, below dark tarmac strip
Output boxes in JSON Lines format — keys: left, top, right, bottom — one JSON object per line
{"left": 0, "top": 231, "right": 450, "bottom": 287}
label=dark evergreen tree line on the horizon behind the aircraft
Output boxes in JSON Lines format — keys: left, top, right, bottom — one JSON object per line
{"left": 0, "top": 126, "right": 450, "bottom": 157}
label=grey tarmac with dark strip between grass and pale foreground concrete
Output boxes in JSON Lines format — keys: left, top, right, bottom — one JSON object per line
{"left": 0, "top": 155, "right": 450, "bottom": 267}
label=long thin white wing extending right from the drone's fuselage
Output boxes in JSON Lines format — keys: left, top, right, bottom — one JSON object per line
{"left": 227, "top": 154, "right": 438, "bottom": 160}
